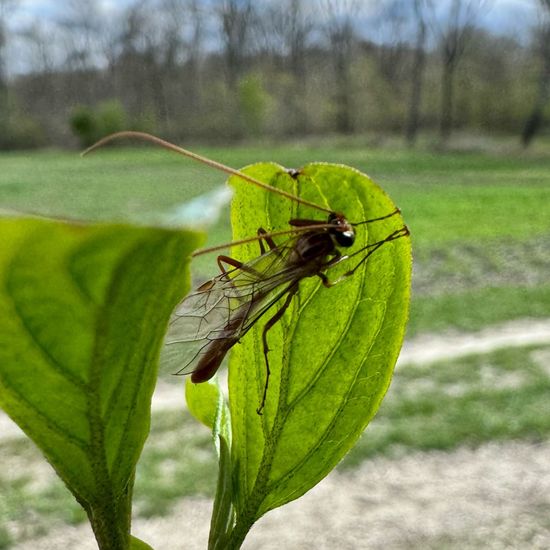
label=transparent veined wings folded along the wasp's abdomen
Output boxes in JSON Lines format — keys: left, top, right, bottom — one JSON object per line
{"left": 161, "top": 238, "right": 306, "bottom": 374}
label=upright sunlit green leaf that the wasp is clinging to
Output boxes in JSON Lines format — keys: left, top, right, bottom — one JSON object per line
{"left": 229, "top": 164, "right": 411, "bottom": 548}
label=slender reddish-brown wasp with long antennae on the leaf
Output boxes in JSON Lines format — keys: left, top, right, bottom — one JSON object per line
{"left": 87, "top": 132, "right": 409, "bottom": 414}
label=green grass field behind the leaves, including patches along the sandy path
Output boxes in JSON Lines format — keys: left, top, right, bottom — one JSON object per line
{"left": 0, "top": 141, "right": 550, "bottom": 549}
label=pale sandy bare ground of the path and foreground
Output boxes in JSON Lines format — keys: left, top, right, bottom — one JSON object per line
{"left": 0, "top": 320, "right": 550, "bottom": 550}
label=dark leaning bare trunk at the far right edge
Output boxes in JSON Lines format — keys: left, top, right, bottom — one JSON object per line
{"left": 521, "top": 0, "right": 550, "bottom": 147}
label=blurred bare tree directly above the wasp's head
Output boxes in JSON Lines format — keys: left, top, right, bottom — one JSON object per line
{"left": 321, "top": 0, "right": 360, "bottom": 134}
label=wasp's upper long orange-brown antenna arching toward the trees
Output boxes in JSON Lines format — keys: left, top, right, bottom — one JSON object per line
{"left": 82, "top": 130, "right": 332, "bottom": 213}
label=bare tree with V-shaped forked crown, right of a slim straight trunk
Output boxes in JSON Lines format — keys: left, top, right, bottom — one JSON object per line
{"left": 429, "top": 0, "right": 490, "bottom": 143}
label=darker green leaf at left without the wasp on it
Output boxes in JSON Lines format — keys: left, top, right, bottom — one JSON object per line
{"left": 0, "top": 219, "right": 202, "bottom": 548}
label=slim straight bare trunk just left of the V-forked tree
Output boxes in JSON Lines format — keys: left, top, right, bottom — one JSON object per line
{"left": 405, "top": 0, "right": 427, "bottom": 146}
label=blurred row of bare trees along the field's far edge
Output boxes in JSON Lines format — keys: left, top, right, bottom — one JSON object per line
{"left": 0, "top": 0, "right": 550, "bottom": 149}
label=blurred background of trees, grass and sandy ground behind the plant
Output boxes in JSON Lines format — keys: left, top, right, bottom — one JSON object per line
{"left": 0, "top": 0, "right": 550, "bottom": 550}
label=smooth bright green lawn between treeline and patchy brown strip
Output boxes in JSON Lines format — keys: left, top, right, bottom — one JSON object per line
{"left": 0, "top": 141, "right": 550, "bottom": 247}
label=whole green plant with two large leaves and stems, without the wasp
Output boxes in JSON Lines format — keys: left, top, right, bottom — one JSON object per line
{"left": 0, "top": 158, "right": 410, "bottom": 549}
